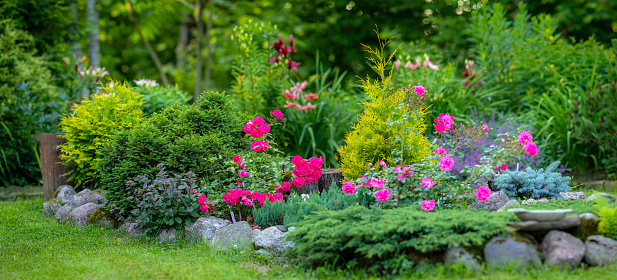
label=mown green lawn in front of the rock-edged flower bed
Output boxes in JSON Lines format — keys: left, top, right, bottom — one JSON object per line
{"left": 0, "top": 199, "right": 617, "bottom": 280}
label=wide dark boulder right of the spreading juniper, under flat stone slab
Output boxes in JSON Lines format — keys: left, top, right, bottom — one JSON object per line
{"left": 484, "top": 234, "right": 542, "bottom": 267}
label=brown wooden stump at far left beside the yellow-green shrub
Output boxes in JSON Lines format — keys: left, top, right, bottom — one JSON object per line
{"left": 39, "top": 133, "right": 69, "bottom": 200}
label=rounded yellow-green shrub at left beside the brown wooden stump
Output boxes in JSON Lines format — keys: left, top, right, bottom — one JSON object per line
{"left": 60, "top": 83, "right": 144, "bottom": 188}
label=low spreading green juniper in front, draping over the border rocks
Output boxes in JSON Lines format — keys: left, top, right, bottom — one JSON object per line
{"left": 287, "top": 206, "right": 514, "bottom": 274}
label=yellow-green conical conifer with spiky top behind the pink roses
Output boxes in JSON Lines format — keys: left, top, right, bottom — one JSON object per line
{"left": 339, "top": 38, "right": 430, "bottom": 179}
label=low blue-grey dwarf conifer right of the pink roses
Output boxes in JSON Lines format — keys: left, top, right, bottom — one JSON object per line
{"left": 495, "top": 161, "right": 571, "bottom": 199}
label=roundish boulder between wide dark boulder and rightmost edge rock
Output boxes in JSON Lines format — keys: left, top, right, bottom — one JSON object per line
{"left": 542, "top": 230, "right": 585, "bottom": 269}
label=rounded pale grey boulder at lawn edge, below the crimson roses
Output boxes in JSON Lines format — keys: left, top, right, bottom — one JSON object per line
{"left": 211, "top": 221, "right": 253, "bottom": 250}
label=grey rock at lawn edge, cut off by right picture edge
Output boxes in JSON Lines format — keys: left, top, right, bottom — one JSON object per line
{"left": 585, "top": 235, "right": 617, "bottom": 266}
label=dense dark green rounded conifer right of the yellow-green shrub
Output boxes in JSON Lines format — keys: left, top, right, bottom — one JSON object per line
{"left": 99, "top": 91, "right": 247, "bottom": 211}
